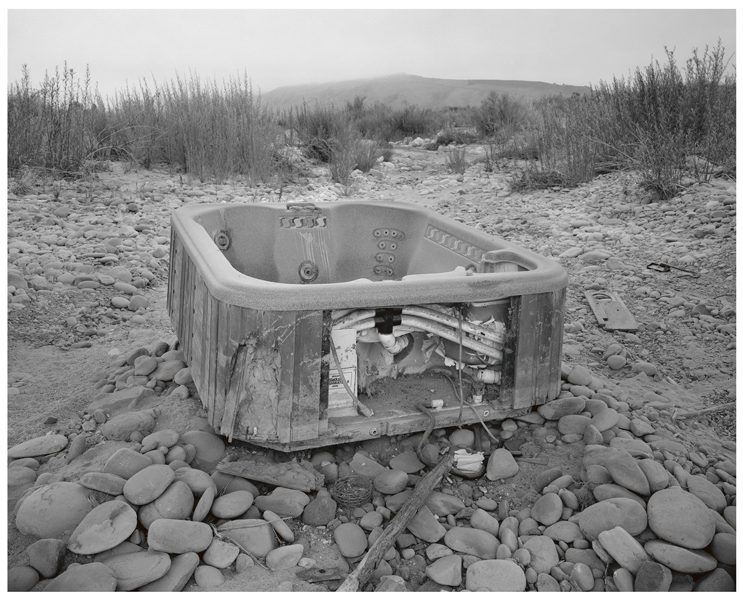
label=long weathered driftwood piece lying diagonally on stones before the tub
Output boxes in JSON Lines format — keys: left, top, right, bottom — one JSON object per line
{"left": 337, "top": 453, "right": 454, "bottom": 592}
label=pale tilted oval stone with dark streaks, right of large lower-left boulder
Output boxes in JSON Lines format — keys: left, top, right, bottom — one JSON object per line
{"left": 67, "top": 500, "right": 137, "bottom": 554}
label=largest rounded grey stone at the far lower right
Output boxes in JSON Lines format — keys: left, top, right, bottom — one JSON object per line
{"left": 648, "top": 488, "right": 715, "bottom": 550}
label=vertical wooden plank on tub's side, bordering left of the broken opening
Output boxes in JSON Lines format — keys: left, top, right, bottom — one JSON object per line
{"left": 291, "top": 311, "right": 323, "bottom": 441}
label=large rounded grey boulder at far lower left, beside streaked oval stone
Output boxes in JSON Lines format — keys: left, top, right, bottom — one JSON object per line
{"left": 16, "top": 481, "right": 93, "bottom": 539}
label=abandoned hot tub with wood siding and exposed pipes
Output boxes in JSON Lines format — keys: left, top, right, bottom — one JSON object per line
{"left": 168, "top": 201, "right": 567, "bottom": 451}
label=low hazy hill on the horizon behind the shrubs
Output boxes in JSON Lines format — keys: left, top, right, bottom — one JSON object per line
{"left": 261, "top": 73, "right": 589, "bottom": 109}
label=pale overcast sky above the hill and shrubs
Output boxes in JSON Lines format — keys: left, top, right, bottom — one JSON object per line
{"left": 7, "top": 9, "right": 736, "bottom": 102}
